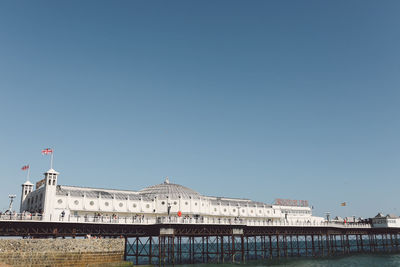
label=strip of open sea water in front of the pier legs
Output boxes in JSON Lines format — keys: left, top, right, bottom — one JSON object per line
{"left": 176, "top": 254, "right": 400, "bottom": 267}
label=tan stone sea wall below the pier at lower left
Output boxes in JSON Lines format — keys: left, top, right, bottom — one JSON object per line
{"left": 0, "top": 238, "right": 125, "bottom": 267}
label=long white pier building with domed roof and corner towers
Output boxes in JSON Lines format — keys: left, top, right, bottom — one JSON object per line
{"left": 20, "top": 169, "right": 324, "bottom": 224}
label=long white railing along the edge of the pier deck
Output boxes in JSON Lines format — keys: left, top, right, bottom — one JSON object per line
{"left": 0, "top": 213, "right": 371, "bottom": 228}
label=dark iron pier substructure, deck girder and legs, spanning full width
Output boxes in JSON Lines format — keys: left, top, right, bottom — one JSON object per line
{"left": 0, "top": 221, "right": 400, "bottom": 265}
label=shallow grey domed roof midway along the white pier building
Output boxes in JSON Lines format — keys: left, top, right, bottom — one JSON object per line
{"left": 139, "top": 178, "right": 201, "bottom": 198}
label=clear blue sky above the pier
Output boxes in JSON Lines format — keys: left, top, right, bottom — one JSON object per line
{"left": 0, "top": 0, "right": 400, "bottom": 219}
